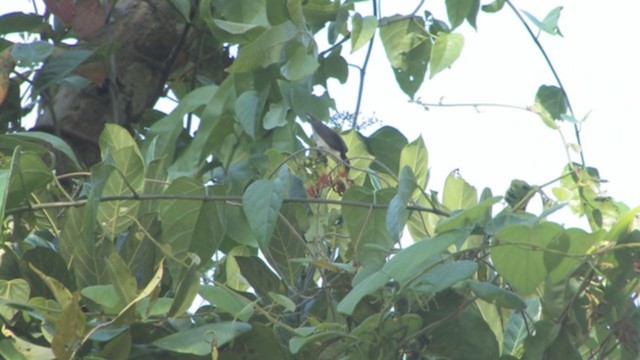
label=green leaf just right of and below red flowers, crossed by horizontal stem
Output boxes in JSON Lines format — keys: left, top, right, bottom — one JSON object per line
{"left": 342, "top": 186, "right": 395, "bottom": 267}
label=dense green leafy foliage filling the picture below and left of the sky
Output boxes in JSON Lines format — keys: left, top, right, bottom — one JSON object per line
{"left": 0, "top": 0, "right": 640, "bottom": 359}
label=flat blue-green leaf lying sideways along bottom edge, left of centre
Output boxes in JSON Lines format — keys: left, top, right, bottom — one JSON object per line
{"left": 153, "top": 322, "right": 251, "bottom": 356}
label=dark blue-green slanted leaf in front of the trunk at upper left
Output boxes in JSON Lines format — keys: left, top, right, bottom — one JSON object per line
{"left": 34, "top": 50, "right": 93, "bottom": 91}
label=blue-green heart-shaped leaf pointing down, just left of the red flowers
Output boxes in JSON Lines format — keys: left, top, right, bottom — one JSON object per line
{"left": 242, "top": 179, "right": 284, "bottom": 249}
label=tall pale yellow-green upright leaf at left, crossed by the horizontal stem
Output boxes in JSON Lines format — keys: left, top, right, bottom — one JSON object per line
{"left": 97, "top": 124, "right": 144, "bottom": 239}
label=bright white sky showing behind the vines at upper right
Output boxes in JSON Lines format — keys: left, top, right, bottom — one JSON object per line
{"left": 0, "top": 0, "right": 640, "bottom": 224}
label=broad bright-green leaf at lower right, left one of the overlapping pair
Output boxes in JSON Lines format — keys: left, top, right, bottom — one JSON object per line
{"left": 491, "top": 222, "right": 564, "bottom": 295}
